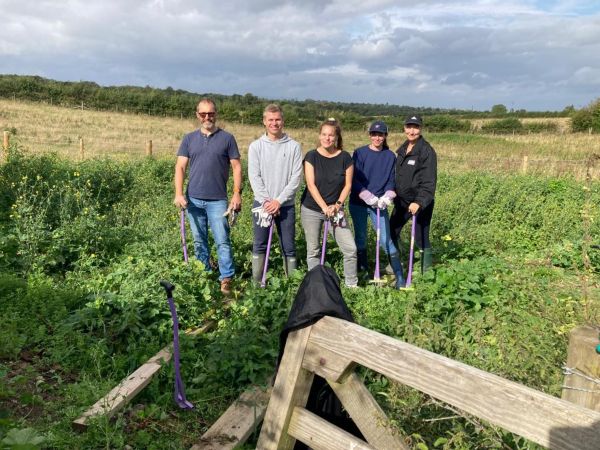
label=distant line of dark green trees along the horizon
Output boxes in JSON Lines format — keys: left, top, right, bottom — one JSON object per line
{"left": 0, "top": 75, "right": 584, "bottom": 132}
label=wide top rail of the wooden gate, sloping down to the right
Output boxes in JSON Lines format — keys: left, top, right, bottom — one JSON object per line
{"left": 310, "top": 317, "right": 600, "bottom": 450}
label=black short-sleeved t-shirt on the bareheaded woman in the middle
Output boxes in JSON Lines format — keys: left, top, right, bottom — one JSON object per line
{"left": 300, "top": 150, "right": 354, "bottom": 212}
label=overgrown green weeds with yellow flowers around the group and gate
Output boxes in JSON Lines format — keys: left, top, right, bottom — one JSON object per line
{"left": 0, "top": 139, "right": 600, "bottom": 449}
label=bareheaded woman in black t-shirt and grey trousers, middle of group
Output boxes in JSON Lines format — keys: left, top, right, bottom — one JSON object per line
{"left": 300, "top": 119, "right": 358, "bottom": 287}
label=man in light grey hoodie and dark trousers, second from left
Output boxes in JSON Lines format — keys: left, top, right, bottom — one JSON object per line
{"left": 248, "top": 104, "right": 302, "bottom": 281}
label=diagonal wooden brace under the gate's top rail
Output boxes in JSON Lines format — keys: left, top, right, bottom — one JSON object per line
{"left": 328, "top": 373, "right": 408, "bottom": 450}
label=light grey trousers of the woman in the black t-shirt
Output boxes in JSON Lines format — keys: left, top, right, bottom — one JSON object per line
{"left": 300, "top": 206, "right": 358, "bottom": 286}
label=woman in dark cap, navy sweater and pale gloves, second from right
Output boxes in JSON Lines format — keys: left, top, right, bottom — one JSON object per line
{"left": 350, "top": 120, "right": 405, "bottom": 289}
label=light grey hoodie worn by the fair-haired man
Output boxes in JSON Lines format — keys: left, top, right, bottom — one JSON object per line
{"left": 248, "top": 134, "right": 302, "bottom": 206}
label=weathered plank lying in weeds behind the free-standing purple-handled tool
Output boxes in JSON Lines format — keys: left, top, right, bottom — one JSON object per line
{"left": 73, "top": 321, "right": 215, "bottom": 430}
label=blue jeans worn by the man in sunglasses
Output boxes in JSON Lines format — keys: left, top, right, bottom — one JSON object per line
{"left": 187, "top": 197, "right": 235, "bottom": 280}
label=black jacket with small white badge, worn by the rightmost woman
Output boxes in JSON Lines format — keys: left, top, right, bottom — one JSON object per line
{"left": 394, "top": 136, "right": 437, "bottom": 209}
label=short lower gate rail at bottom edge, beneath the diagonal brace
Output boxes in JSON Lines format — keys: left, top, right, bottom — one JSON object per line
{"left": 288, "top": 407, "right": 376, "bottom": 450}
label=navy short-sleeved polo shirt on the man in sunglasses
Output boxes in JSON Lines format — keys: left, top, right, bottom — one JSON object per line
{"left": 177, "top": 128, "right": 240, "bottom": 200}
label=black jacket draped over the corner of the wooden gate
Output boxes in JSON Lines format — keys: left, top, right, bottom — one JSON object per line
{"left": 277, "top": 265, "right": 364, "bottom": 450}
